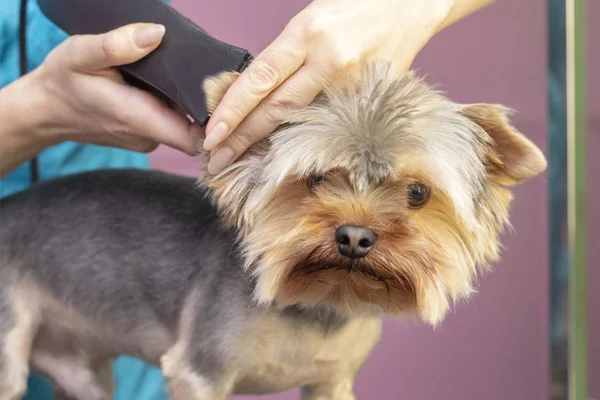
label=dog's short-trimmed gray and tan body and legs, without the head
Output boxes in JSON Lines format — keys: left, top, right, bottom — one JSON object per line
{"left": 0, "top": 170, "right": 380, "bottom": 400}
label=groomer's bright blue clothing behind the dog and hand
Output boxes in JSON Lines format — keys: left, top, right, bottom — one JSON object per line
{"left": 0, "top": 0, "right": 167, "bottom": 400}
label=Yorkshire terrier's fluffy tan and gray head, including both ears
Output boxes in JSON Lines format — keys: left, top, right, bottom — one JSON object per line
{"left": 200, "top": 63, "right": 546, "bottom": 325}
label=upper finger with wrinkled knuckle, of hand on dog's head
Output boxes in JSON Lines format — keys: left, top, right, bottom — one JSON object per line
{"left": 204, "top": 28, "right": 307, "bottom": 151}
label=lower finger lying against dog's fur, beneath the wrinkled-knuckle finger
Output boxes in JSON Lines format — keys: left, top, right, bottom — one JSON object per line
{"left": 207, "top": 67, "right": 323, "bottom": 175}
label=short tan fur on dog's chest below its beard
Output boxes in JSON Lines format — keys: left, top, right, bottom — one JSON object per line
{"left": 234, "top": 314, "right": 381, "bottom": 394}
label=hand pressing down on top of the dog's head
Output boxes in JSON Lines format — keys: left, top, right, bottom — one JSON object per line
{"left": 204, "top": 0, "right": 455, "bottom": 174}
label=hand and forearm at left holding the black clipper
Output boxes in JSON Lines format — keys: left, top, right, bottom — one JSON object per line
{"left": 0, "top": 24, "right": 203, "bottom": 177}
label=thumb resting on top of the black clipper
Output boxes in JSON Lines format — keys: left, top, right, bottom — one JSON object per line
{"left": 65, "top": 23, "right": 165, "bottom": 72}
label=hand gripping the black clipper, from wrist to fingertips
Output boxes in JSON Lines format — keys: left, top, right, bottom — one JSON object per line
{"left": 32, "top": 23, "right": 203, "bottom": 155}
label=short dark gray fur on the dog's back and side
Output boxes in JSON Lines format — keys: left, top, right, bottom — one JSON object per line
{"left": 0, "top": 169, "right": 251, "bottom": 330}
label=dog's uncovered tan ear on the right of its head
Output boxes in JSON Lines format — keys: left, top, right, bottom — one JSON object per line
{"left": 462, "top": 104, "right": 547, "bottom": 185}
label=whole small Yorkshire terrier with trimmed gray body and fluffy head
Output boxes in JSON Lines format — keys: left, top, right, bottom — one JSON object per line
{"left": 0, "top": 62, "right": 546, "bottom": 400}
